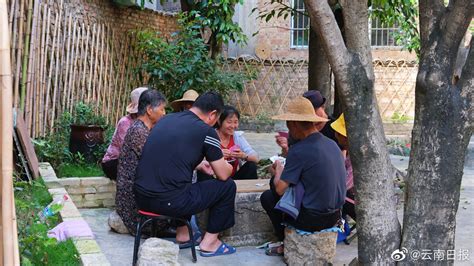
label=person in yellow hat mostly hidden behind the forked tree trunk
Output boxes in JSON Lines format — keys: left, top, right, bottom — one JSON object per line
{"left": 331, "top": 114, "right": 357, "bottom": 220}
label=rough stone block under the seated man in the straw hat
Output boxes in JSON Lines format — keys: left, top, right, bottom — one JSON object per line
{"left": 284, "top": 228, "right": 337, "bottom": 266}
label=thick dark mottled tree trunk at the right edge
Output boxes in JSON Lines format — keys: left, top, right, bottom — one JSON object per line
{"left": 401, "top": 0, "right": 474, "bottom": 262}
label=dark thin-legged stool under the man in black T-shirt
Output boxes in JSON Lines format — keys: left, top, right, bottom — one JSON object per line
{"left": 133, "top": 210, "right": 197, "bottom": 265}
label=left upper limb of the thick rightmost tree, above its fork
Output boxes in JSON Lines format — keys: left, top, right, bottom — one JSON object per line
{"left": 418, "top": 0, "right": 446, "bottom": 47}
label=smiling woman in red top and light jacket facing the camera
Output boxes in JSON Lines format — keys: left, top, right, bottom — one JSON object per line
{"left": 198, "top": 105, "right": 259, "bottom": 181}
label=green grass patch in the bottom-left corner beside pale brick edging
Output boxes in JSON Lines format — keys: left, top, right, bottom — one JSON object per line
{"left": 15, "top": 180, "right": 80, "bottom": 265}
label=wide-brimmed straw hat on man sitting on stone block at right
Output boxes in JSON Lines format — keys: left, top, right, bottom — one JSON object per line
{"left": 272, "top": 97, "right": 329, "bottom": 122}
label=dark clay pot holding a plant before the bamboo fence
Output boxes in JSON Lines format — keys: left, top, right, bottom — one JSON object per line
{"left": 69, "top": 125, "right": 104, "bottom": 162}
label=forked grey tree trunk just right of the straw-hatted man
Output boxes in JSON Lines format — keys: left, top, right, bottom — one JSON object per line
{"left": 305, "top": 0, "right": 400, "bottom": 264}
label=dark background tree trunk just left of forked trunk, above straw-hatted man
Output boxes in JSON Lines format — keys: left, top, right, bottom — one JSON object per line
{"left": 308, "top": 28, "right": 331, "bottom": 101}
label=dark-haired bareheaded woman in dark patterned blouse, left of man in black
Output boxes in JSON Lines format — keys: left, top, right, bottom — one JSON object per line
{"left": 115, "top": 89, "right": 167, "bottom": 234}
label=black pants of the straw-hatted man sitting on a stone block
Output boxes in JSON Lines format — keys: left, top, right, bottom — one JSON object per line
{"left": 260, "top": 182, "right": 341, "bottom": 241}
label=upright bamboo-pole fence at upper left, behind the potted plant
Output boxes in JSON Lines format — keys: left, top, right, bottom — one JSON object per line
{"left": 9, "top": 0, "right": 142, "bottom": 138}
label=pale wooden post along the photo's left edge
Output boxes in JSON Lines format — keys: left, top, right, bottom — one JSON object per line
{"left": 0, "top": 0, "right": 20, "bottom": 265}
